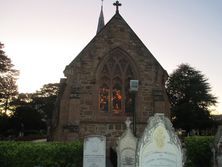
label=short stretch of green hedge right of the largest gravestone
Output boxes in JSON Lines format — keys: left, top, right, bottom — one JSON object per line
{"left": 185, "top": 136, "right": 214, "bottom": 167}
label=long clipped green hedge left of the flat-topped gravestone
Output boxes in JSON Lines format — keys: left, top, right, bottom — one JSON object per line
{"left": 0, "top": 141, "right": 83, "bottom": 167}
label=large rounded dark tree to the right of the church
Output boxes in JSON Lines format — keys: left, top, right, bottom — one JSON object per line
{"left": 166, "top": 64, "right": 217, "bottom": 132}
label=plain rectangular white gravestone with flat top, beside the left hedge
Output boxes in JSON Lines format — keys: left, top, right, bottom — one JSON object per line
{"left": 83, "top": 135, "right": 106, "bottom": 167}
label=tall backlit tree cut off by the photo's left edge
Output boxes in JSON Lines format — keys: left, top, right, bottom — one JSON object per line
{"left": 0, "top": 43, "right": 19, "bottom": 113}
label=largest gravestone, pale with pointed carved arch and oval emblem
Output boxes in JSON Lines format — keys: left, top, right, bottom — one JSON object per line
{"left": 136, "top": 113, "right": 183, "bottom": 167}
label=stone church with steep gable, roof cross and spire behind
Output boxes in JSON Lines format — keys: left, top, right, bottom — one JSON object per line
{"left": 53, "top": 1, "right": 170, "bottom": 150}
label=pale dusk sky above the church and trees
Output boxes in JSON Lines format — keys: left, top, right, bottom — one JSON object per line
{"left": 0, "top": 0, "right": 222, "bottom": 114}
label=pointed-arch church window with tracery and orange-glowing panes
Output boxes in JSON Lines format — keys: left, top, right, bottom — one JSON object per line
{"left": 97, "top": 49, "right": 137, "bottom": 114}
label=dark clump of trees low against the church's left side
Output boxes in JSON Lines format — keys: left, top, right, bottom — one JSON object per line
{"left": 0, "top": 83, "right": 59, "bottom": 139}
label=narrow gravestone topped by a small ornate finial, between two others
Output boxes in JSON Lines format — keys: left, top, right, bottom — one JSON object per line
{"left": 117, "top": 117, "right": 137, "bottom": 167}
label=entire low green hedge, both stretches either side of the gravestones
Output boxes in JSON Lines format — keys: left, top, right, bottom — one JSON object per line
{"left": 0, "top": 136, "right": 214, "bottom": 167}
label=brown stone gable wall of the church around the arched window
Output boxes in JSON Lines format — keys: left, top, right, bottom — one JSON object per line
{"left": 53, "top": 13, "right": 169, "bottom": 151}
